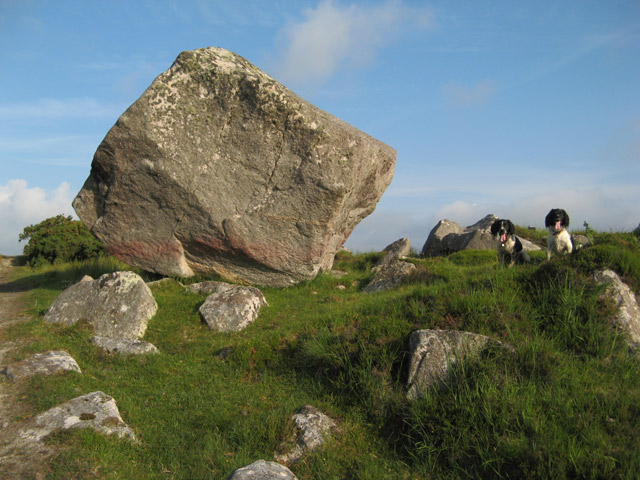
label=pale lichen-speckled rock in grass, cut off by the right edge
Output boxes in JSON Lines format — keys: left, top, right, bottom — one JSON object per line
{"left": 594, "top": 270, "right": 640, "bottom": 352}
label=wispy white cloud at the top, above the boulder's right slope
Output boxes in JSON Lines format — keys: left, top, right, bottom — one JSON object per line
{"left": 275, "top": 0, "right": 433, "bottom": 84}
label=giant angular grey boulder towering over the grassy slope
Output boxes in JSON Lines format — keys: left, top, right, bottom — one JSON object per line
{"left": 73, "top": 48, "right": 395, "bottom": 286}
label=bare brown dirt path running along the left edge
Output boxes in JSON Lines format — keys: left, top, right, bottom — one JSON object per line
{"left": 0, "top": 257, "right": 52, "bottom": 480}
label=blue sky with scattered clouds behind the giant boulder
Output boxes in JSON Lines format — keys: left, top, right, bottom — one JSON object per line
{"left": 0, "top": 0, "right": 640, "bottom": 254}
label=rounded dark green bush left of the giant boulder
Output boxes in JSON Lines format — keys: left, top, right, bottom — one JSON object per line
{"left": 18, "top": 215, "right": 106, "bottom": 267}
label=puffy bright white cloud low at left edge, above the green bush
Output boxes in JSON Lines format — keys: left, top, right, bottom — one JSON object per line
{"left": 0, "top": 180, "right": 75, "bottom": 255}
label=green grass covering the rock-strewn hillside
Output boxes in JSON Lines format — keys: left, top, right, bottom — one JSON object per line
{"left": 1, "top": 231, "right": 640, "bottom": 479}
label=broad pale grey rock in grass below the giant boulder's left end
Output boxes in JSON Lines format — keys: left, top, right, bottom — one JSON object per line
{"left": 44, "top": 272, "right": 158, "bottom": 340}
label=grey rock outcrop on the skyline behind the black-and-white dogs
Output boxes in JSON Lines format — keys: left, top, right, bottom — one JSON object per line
{"left": 422, "top": 213, "right": 540, "bottom": 257}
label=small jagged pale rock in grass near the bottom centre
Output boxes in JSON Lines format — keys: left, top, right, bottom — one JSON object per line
{"left": 275, "top": 405, "right": 338, "bottom": 465}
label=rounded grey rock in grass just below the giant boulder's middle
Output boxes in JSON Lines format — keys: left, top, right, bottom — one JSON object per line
{"left": 199, "top": 284, "right": 267, "bottom": 332}
